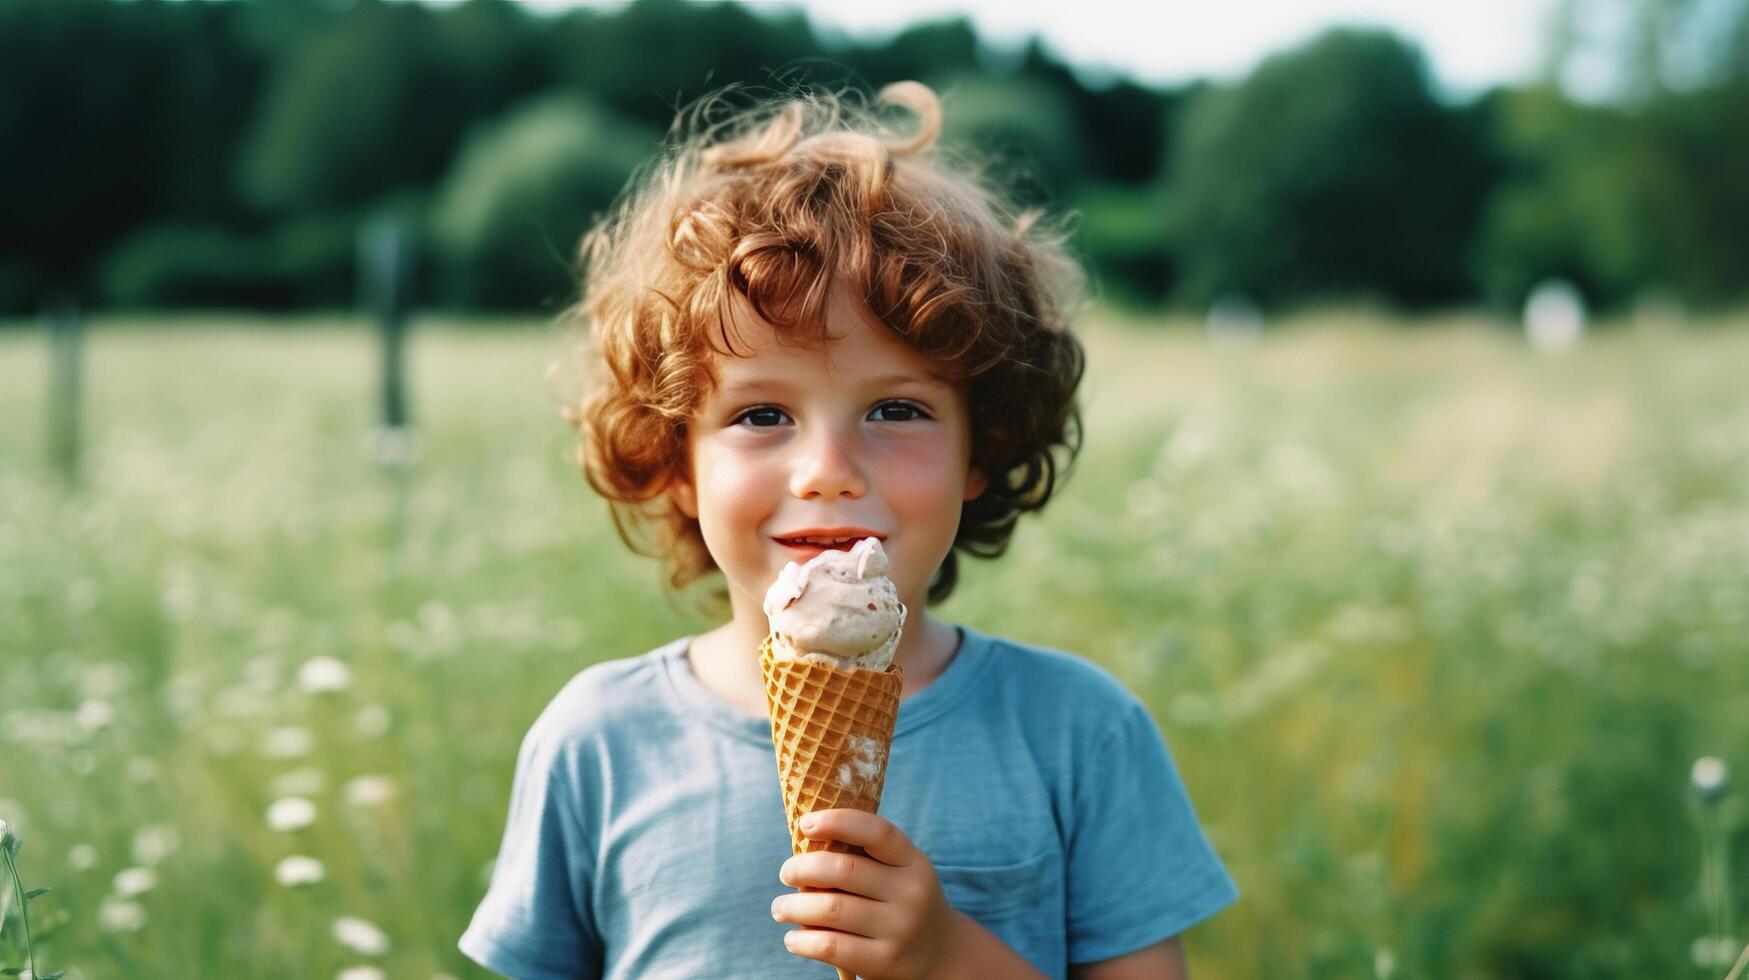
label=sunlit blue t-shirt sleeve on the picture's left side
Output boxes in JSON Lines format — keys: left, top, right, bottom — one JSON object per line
{"left": 456, "top": 712, "right": 602, "bottom": 980}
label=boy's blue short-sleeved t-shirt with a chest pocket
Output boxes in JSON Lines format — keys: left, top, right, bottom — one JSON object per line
{"left": 458, "top": 627, "right": 1238, "bottom": 980}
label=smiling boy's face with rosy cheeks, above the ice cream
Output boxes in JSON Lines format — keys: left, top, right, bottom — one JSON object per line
{"left": 670, "top": 278, "right": 985, "bottom": 620}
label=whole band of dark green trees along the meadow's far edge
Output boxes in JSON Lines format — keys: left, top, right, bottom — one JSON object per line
{"left": 0, "top": 0, "right": 1749, "bottom": 315}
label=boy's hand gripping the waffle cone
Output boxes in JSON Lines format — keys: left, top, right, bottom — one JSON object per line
{"left": 771, "top": 810, "right": 958, "bottom": 980}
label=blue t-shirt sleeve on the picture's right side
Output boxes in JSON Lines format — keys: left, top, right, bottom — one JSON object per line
{"left": 1065, "top": 697, "right": 1238, "bottom": 964}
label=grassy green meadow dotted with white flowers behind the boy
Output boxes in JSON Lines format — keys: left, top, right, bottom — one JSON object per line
{"left": 0, "top": 312, "right": 1749, "bottom": 980}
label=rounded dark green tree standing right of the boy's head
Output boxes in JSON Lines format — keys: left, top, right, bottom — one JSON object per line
{"left": 1165, "top": 30, "right": 1490, "bottom": 305}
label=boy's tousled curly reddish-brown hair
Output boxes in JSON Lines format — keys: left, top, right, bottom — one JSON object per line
{"left": 560, "top": 82, "right": 1086, "bottom": 604}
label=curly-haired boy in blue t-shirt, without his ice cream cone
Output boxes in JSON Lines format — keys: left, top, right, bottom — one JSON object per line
{"left": 460, "top": 82, "right": 1238, "bottom": 980}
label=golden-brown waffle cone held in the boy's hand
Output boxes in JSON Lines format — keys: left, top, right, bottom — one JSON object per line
{"left": 759, "top": 637, "right": 901, "bottom": 980}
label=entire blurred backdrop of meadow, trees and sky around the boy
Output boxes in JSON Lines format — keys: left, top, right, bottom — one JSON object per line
{"left": 0, "top": 0, "right": 1749, "bottom": 980}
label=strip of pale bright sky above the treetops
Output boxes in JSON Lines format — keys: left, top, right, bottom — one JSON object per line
{"left": 489, "top": 0, "right": 1551, "bottom": 96}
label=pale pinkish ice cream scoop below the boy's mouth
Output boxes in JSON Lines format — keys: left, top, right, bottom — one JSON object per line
{"left": 764, "top": 537, "right": 906, "bottom": 670}
